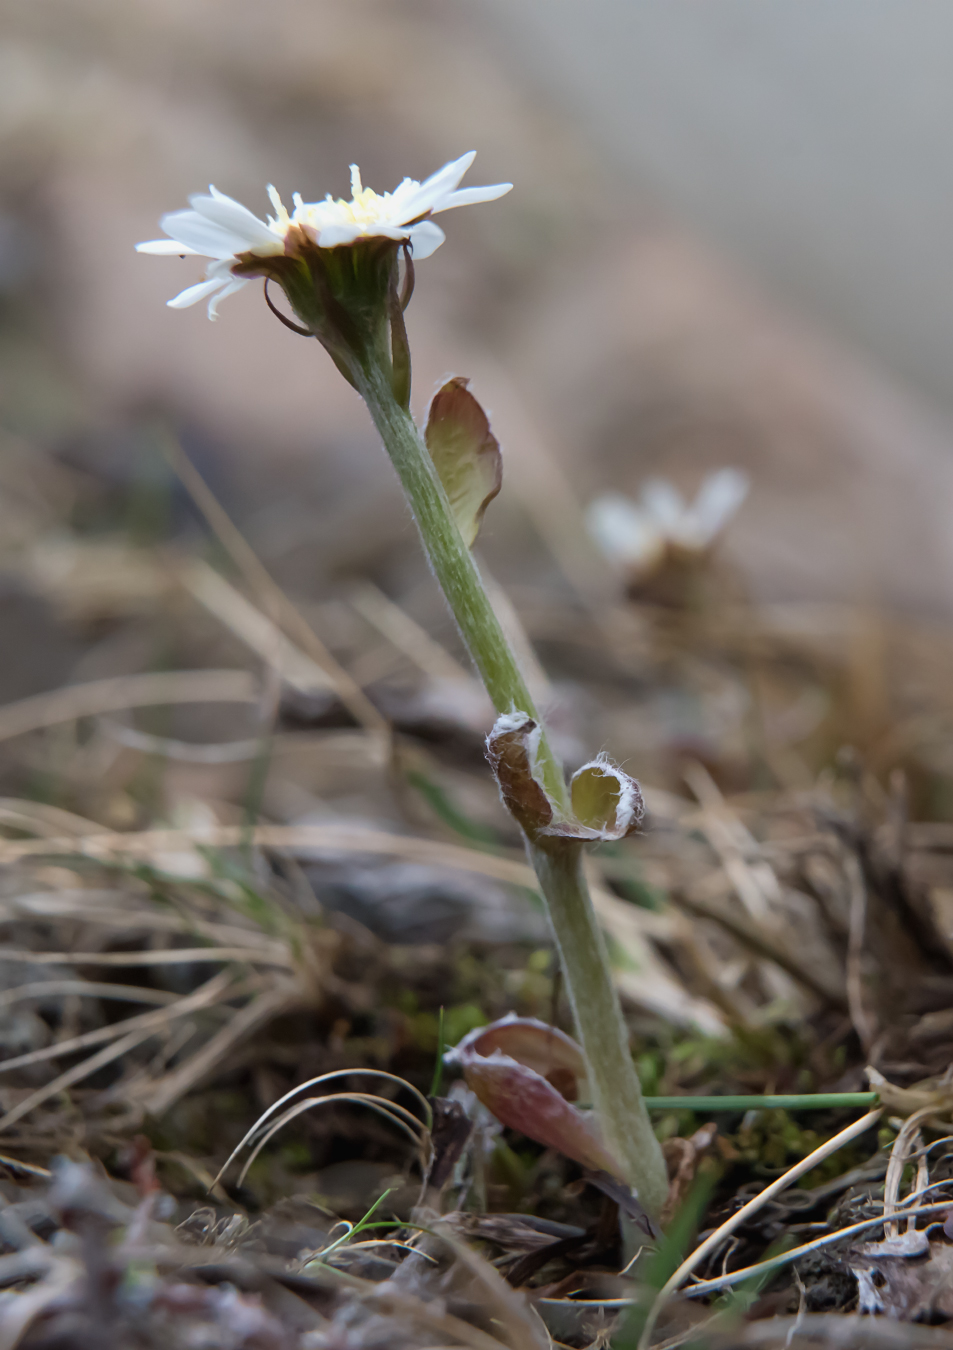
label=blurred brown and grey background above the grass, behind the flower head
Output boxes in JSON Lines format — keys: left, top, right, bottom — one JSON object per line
{"left": 0, "top": 0, "right": 953, "bottom": 622}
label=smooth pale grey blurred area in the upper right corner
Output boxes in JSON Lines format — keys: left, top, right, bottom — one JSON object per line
{"left": 478, "top": 0, "right": 953, "bottom": 408}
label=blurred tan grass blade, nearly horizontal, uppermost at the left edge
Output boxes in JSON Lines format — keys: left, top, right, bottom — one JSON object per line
{"left": 0, "top": 671, "right": 259, "bottom": 741}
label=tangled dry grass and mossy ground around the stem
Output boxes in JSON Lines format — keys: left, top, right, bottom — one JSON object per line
{"left": 0, "top": 415, "right": 953, "bottom": 1350}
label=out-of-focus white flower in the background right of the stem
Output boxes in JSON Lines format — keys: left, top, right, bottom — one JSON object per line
{"left": 586, "top": 468, "right": 751, "bottom": 571}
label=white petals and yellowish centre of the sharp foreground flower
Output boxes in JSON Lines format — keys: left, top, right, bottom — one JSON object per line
{"left": 136, "top": 150, "right": 513, "bottom": 319}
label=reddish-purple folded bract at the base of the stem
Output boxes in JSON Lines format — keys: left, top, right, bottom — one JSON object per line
{"left": 445, "top": 1017, "right": 625, "bottom": 1180}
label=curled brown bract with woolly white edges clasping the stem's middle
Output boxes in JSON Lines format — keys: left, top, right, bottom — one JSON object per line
{"left": 486, "top": 713, "right": 645, "bottom": 841}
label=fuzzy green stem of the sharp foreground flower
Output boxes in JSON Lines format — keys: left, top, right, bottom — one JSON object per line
{"left": 354, "top": 362, "right": 668, "bottom": 1218}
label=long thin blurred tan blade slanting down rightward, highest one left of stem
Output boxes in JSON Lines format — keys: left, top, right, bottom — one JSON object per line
{"left": 166, "top": 436, "right": 390, "bottom": 736}
